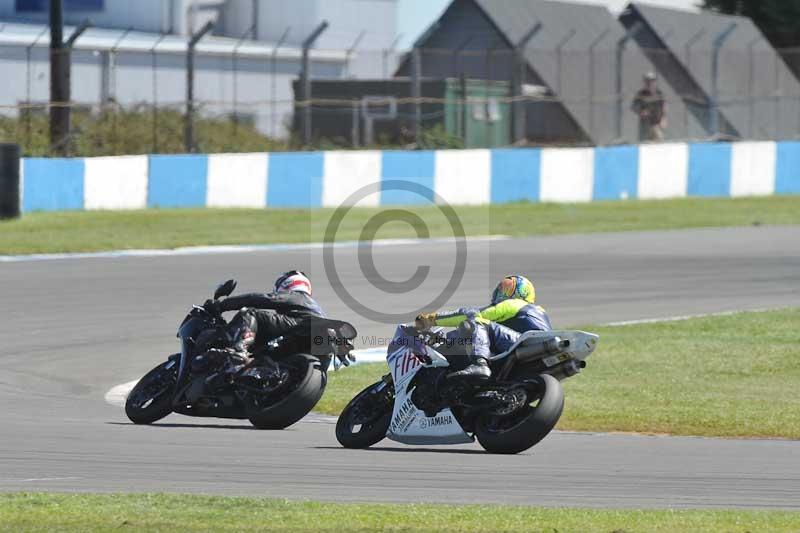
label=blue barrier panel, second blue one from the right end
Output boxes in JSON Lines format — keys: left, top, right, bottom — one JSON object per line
{"left": 687, "top": 143, "right": 732, "bottom": 196}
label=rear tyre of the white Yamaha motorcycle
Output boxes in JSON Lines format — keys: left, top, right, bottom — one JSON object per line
{"left": 475, "top": 374, "right": 564, "bottom": 454}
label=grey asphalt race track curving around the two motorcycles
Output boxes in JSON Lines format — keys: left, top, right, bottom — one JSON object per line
{"left": 0, "top": 227, "right": 800, "bottom": 510}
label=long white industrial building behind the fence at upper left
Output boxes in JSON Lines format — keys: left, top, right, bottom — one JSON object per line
{"left": 0, "top": 0, "right": 397, "bottom": 138}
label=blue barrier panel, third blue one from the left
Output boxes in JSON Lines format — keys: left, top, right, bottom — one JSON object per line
{"left": 267, "top": 152, "right": 325, "bottom": 207}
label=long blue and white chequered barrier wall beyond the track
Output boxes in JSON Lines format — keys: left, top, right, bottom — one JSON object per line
{"left": 21, "top": 142, "right": 800, "bottom": 212}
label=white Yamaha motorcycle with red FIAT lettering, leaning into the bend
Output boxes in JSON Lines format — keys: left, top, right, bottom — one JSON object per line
{"left": 336, "top": 325, "right": 599, "bottom": 454}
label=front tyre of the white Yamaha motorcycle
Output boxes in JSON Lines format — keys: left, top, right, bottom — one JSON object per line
{"left": 336, "top": 381, "right": 394, "bottom": 448}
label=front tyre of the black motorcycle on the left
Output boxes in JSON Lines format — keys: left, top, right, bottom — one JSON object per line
{"left": 125, "top": 361, "right": 178, "bottom": 424}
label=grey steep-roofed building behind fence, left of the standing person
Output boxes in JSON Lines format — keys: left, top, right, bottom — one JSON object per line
{"left": 398, "top": 0, "right": 700, "bottom": 144}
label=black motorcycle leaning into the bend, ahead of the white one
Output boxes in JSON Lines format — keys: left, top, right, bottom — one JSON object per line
{"left": 125, "top": 280, "right": 356, "bottom": 429}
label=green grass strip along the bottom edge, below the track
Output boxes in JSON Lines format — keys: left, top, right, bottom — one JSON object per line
{"left": 0, "top": 494, "right": 800, "bottom": 533}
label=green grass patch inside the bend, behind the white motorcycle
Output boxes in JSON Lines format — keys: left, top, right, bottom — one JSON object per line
{"left": 318, "top": 309, "right": 800, "bottom": 439}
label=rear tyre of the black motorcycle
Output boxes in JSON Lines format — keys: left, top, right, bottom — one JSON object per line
{"left": 245, "top": 354, "right": 327, "bottom": 429}
